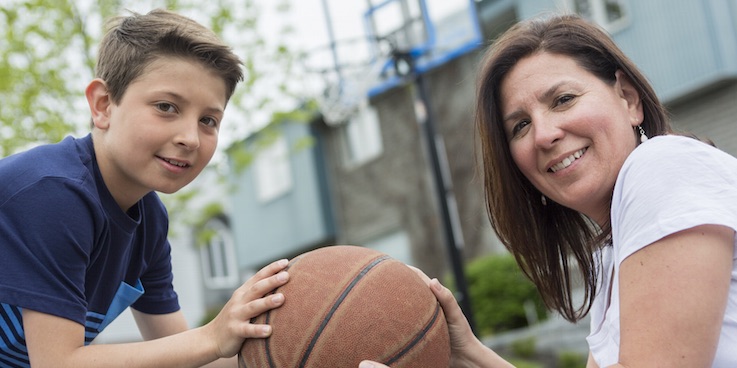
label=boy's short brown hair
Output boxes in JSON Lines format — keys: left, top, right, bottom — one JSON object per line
{"left": 95, "top": 9, "right": 243, "bottom": 104}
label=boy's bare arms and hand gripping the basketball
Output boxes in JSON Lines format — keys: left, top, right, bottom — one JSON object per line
{"left": 23, "top": 260, "right": 289, "bottom": 368}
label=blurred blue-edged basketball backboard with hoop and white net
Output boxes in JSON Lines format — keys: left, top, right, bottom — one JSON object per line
{"left": 305, "top": 0, "right": 482, "bottom": 123}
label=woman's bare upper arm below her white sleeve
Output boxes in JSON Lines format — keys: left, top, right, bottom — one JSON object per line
{"left": 617, "top": 225, "right": 735, "bottom": 368}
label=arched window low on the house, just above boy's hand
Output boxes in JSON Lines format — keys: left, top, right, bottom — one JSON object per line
{"left": 200, "top": 218, "right": 239, "bottom": 289}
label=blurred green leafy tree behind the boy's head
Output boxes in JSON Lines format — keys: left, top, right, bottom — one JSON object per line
{"left": 0, "top": 0, "right": 310, "bottom": 157}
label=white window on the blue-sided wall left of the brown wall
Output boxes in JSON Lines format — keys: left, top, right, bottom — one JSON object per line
{"left": 254, "top": 137, "right": 292, "bottom": 202}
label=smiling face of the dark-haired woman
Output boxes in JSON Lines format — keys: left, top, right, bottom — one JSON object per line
{"left": 500, "top": 52, "right": 643, "bottom": 224}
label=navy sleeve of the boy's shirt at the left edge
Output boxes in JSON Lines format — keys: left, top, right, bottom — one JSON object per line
{"left": 0, "top": 178, "right": 101, "bottom": 323}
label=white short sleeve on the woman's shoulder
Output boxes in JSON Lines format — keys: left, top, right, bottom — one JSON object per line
{"left": 612, "top": 136, "right": 737, "bottom": 263}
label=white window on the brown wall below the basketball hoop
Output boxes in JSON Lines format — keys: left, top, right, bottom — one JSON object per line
{"left": 343, "top": 105, "right": 383, "bottom": 165}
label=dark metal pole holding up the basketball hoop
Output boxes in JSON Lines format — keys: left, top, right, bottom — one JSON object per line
{"left": 412, "top": 68, "right": 476, "bottom": 333}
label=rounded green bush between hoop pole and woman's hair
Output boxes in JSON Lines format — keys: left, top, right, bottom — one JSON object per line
{"left": 466, "top": 254, "right": 547, "bottom": 336}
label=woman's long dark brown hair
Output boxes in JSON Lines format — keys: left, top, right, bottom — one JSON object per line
{"left": 476, "top": 15, "right": 671, "bottom": 321}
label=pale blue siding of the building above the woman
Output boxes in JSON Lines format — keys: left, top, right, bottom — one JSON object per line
{"left": 518, "top": 0, "right": 737, "bottom": 102}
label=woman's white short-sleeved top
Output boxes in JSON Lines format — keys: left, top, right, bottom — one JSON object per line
{"left": 587, "top": 136, "right": 737, "bottom": 368}
